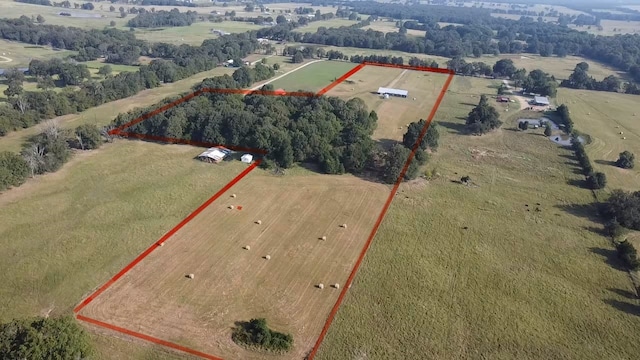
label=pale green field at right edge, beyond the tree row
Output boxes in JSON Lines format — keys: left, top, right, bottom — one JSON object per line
{"left": 557, "top": 88, "right": 640, "bottom": 191}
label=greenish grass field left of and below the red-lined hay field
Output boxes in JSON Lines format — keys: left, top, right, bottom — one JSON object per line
{"left": 0, "top": 140, "right": 250, "bottom": 359}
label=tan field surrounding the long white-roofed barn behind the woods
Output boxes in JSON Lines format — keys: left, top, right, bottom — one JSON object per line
{"left": 326, "top": 65, "right": 447, "bottom": 142}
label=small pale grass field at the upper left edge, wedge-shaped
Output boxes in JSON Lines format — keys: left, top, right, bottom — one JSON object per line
{"left": 0, "top": 39, "right": 75, "bottom": 69}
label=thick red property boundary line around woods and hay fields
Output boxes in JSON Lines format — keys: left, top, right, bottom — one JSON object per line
{"left": 73, "top": 62, "right": 455, "bottom": 360}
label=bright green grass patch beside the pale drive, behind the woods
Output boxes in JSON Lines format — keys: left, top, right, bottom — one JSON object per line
{"left": 271, "top": 61, "right": 356, "bottom": 92}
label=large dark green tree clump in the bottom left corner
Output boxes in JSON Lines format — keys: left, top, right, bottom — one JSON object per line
{"left": 0, "top": 316, "right": 94, "bottom": 360}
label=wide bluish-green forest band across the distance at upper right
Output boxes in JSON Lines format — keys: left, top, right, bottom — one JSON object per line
{"left": 258, "top": 2, "right": 640, "bottom": 82}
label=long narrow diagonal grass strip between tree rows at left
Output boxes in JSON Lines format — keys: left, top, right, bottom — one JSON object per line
{"left": 0, "top": 67, "right": 235, "bottom": 151}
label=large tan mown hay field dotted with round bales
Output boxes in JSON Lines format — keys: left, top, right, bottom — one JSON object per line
{"left": 80, "top": 167, "right": 389, "bottom": 359}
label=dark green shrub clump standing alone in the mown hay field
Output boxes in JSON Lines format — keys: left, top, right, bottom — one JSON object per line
{"left": 231, "top": 318, "right": 293, "bottom": 352}
